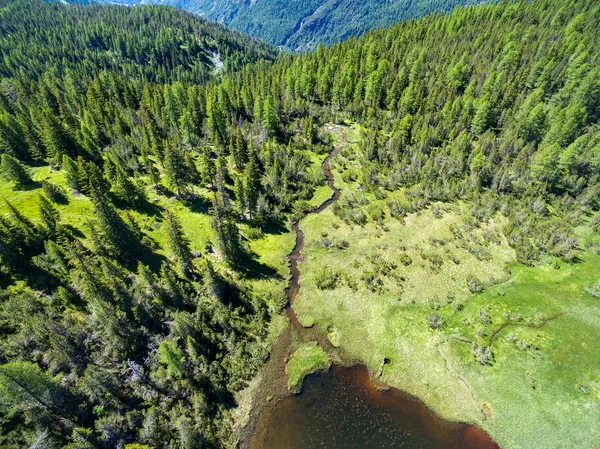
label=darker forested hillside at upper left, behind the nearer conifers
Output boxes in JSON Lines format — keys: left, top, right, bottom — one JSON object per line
{"left": 0, "top": 1, "right": 276, "bottom": 83}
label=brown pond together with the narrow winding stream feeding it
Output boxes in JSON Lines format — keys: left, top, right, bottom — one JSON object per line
{"left": 241, "top": 131, "right": 498, "bottom": 449}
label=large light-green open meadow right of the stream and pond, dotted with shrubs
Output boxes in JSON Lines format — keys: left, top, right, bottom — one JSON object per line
{"left": 294, "top": 124, "right": 600, "bottom": 448}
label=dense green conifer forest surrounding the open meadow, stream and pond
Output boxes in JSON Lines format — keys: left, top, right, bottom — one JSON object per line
{"left": 0, "top": 0, "right": 600, "bottom": 449}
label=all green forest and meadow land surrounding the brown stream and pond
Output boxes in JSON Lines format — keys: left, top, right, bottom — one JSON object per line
{"left": 0, "top": 0, "right": 600, "bottom": 449}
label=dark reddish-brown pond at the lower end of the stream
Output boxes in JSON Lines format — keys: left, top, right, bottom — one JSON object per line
{"left": 251, "top": 366, "right": 498, "bottom": 449}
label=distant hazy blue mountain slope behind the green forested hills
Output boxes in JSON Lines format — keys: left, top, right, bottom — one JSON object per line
{"left": 62, "top": 0, "right": 492, "bottom": 51}
